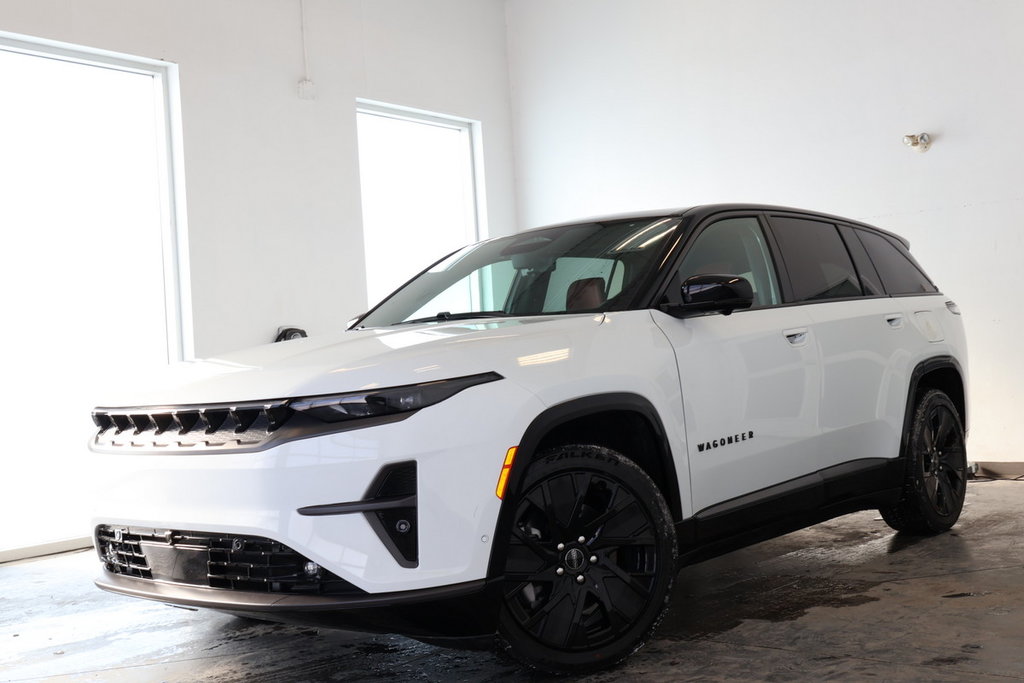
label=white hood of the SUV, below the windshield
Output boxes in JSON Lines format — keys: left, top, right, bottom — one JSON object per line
{"left": 97, "top": 314, "right": 604, "bottom": 408}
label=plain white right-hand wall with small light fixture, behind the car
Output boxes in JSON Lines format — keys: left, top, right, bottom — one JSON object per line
{"left": 507, "top": 0, "right": 1024, "bottom": 461}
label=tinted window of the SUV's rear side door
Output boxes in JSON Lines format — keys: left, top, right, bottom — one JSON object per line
{"left": 771, "top": 216, "right": 863, "bottom": 301}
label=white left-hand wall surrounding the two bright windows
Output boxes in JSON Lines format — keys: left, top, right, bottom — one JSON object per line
{"left": 0, "top": 0, "right": 515, "bottom": 355}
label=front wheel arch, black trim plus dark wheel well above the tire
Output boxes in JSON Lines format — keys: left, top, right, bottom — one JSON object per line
{"left": 487, "top": 393, "right": 682, "bottom": 578}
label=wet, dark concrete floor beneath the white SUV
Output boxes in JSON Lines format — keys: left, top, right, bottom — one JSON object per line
{"left": 0, "top": 480, "right": 1024, "bottom": 682}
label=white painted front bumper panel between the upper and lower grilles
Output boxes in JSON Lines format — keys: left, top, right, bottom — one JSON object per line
{"left": 92, "top": 381, "right": 542, "bottom": 599}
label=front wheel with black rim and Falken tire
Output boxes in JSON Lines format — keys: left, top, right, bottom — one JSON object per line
{"left": 499, "top": 445, "right": 677, "bottom": 674}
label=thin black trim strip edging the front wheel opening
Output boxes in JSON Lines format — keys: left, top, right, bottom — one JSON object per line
{"left": 486, "top": 392, "right": 682, "bottom": 579}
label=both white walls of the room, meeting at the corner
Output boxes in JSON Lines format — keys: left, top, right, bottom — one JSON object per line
{"left": 0, "top": 0, "right": 1024, "bottom": 460}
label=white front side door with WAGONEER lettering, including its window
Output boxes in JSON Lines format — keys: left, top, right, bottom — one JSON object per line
{"left": 654, "top": 216, "right": 820, "bottom": 513}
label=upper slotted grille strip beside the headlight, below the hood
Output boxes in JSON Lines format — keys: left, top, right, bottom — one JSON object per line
{"left": 92, "top": 400, "right": 295, "bottom": 451}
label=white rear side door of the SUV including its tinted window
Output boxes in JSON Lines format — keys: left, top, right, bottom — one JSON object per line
{"left": 770, "top": 214, "right": 916, "bottom": 476}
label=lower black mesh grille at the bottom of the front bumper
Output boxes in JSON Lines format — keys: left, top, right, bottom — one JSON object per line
{"left": 96, "top": 525, "right": 365, "bottom": 596}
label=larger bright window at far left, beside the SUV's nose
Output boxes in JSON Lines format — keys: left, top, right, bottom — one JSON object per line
{"left": 0, "top": 35, "right": 187, "bottom": 553}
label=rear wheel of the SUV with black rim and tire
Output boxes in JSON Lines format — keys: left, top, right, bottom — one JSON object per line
{"left": 880, "top": 389, "right": 967, "bottom": 535}
